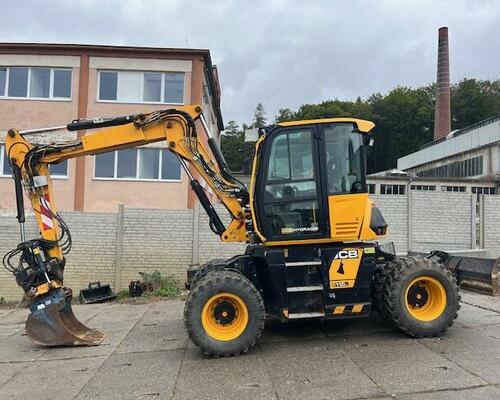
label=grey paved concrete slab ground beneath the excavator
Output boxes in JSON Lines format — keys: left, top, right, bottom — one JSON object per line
{"left": 0, "top": 293, "right": 500, "bottom": 400}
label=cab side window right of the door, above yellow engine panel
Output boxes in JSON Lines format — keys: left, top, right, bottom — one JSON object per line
{"left": 323, "top": 123, "right": 365, "bottom": 194}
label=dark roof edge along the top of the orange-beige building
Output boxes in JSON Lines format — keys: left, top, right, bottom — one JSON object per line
{"left": 0, "top": 42, "right": 224, "bottom": 130}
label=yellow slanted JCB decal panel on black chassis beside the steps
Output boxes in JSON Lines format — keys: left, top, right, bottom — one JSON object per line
{"left": 329, "top": 249, "right": 363, "bottom": 289}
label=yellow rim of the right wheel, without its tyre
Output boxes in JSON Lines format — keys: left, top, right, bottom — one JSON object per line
{"left": 405, "top": 276, "right": 446, "bottom": 322}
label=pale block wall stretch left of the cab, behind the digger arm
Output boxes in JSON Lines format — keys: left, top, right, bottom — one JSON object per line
{"left": 0, "top": 205, "right": 245, "bottom": 300}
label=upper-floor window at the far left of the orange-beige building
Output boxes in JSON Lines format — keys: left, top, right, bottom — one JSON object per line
{"left": 0, "top": 67, "right": 71, "bottom": 100}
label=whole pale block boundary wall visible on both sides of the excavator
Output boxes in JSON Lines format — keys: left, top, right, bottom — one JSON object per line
{"left": 0, "top": 192, "right": 500, "bottom": 300}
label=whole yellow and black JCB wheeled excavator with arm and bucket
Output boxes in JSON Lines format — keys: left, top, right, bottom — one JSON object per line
{"left": 4, "top": 106, "right": 459, "bottom": 356}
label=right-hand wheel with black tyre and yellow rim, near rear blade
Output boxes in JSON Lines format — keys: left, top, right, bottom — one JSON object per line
{"left": 373, "top": 257, "right": 460, "bottom": 338}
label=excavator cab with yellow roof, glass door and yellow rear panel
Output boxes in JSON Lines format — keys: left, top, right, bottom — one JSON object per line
{"left": 254, "top": 119, "right": 387, "bottom": 244}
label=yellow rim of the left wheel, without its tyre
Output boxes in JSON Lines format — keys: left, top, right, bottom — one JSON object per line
{"left": 201, "top": 293, "right": 248, "bottom": 341}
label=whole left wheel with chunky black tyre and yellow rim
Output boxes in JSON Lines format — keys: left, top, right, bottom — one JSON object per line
{"left": 184, "top": 270, "right": 265, "bottom": 357}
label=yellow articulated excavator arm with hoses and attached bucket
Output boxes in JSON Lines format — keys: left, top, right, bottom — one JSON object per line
{"left": 3, "top": 106, "right": 250, "bottom": 345}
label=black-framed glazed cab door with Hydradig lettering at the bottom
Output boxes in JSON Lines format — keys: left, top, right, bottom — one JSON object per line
{"left": 256, "top": 125, "right": 329, "bottom": 241}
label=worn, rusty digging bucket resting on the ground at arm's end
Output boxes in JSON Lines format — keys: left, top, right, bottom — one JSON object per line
{"left": 26, "top": 288, "right": 104, "bottom": 346}
